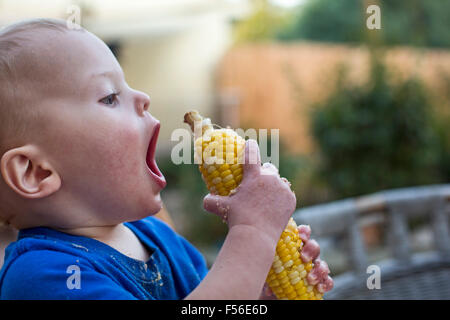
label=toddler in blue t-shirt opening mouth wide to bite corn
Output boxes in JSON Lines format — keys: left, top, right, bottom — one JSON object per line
{"left": 0, "top": 19, "right": 332, "bottom": 299}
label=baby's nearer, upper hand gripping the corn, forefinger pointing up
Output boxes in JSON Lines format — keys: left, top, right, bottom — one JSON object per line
{"left": 203, "top": 140, "right": 296, "bottom": 241}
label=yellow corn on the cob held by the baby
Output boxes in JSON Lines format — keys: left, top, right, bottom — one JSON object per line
{"left": 184, "top": 111, "right": 322, "bottom": 300}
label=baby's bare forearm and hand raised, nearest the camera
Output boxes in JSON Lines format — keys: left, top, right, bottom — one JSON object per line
{"left": 186, "top": 140, "right": 296, "bottom": 300}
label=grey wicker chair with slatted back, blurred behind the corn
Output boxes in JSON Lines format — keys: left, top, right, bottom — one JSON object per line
{"left": 294, "top": 184, "right": 450, "bottom": 299}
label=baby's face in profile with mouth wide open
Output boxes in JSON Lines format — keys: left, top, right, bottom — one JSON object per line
{"left": 30, "top": 31, "right": 166, "bottom": 228}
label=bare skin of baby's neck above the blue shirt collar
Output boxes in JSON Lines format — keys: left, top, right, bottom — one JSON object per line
{"left": 55, "top": 224, "right": 150, "bottom": 262}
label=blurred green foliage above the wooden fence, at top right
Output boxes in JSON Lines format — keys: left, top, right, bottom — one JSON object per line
{"left": 277, "top": 0, "right": 450, "bottom": 47}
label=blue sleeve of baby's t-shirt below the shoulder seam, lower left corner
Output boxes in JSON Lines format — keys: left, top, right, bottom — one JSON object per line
{"left": 0, "top": 250, "right": 137, "bottom": 300}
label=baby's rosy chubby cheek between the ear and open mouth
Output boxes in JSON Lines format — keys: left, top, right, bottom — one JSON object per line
{"left": 54, "top": 121, "right": 161, "bottom": 221}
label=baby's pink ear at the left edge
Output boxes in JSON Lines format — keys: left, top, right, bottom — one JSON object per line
{"left": 0, "top": 145, "right": 61, "bottom": 199}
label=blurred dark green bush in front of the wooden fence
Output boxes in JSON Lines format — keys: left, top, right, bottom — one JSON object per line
{"left": 312, "top": 56, "right": 442, "bottom": 198}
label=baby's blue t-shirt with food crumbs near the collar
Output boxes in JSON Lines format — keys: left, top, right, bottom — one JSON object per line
{"left": 0, "top": 217, "right": 208, "bottom": 300}
